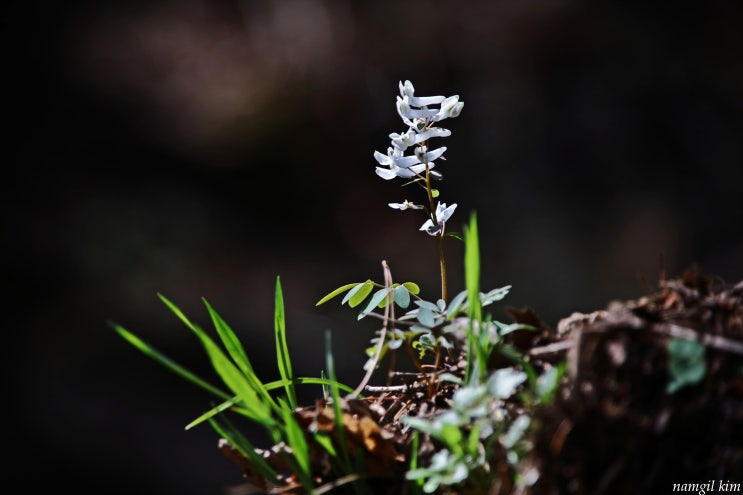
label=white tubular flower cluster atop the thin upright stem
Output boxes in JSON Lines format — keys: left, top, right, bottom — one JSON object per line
{"left": 374, "top": 81, "right": 464, "bottom": 235}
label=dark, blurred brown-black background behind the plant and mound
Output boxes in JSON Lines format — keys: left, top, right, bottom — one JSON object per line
{"left": 2, "top": 0, "right": 743, "bottom": 495}
